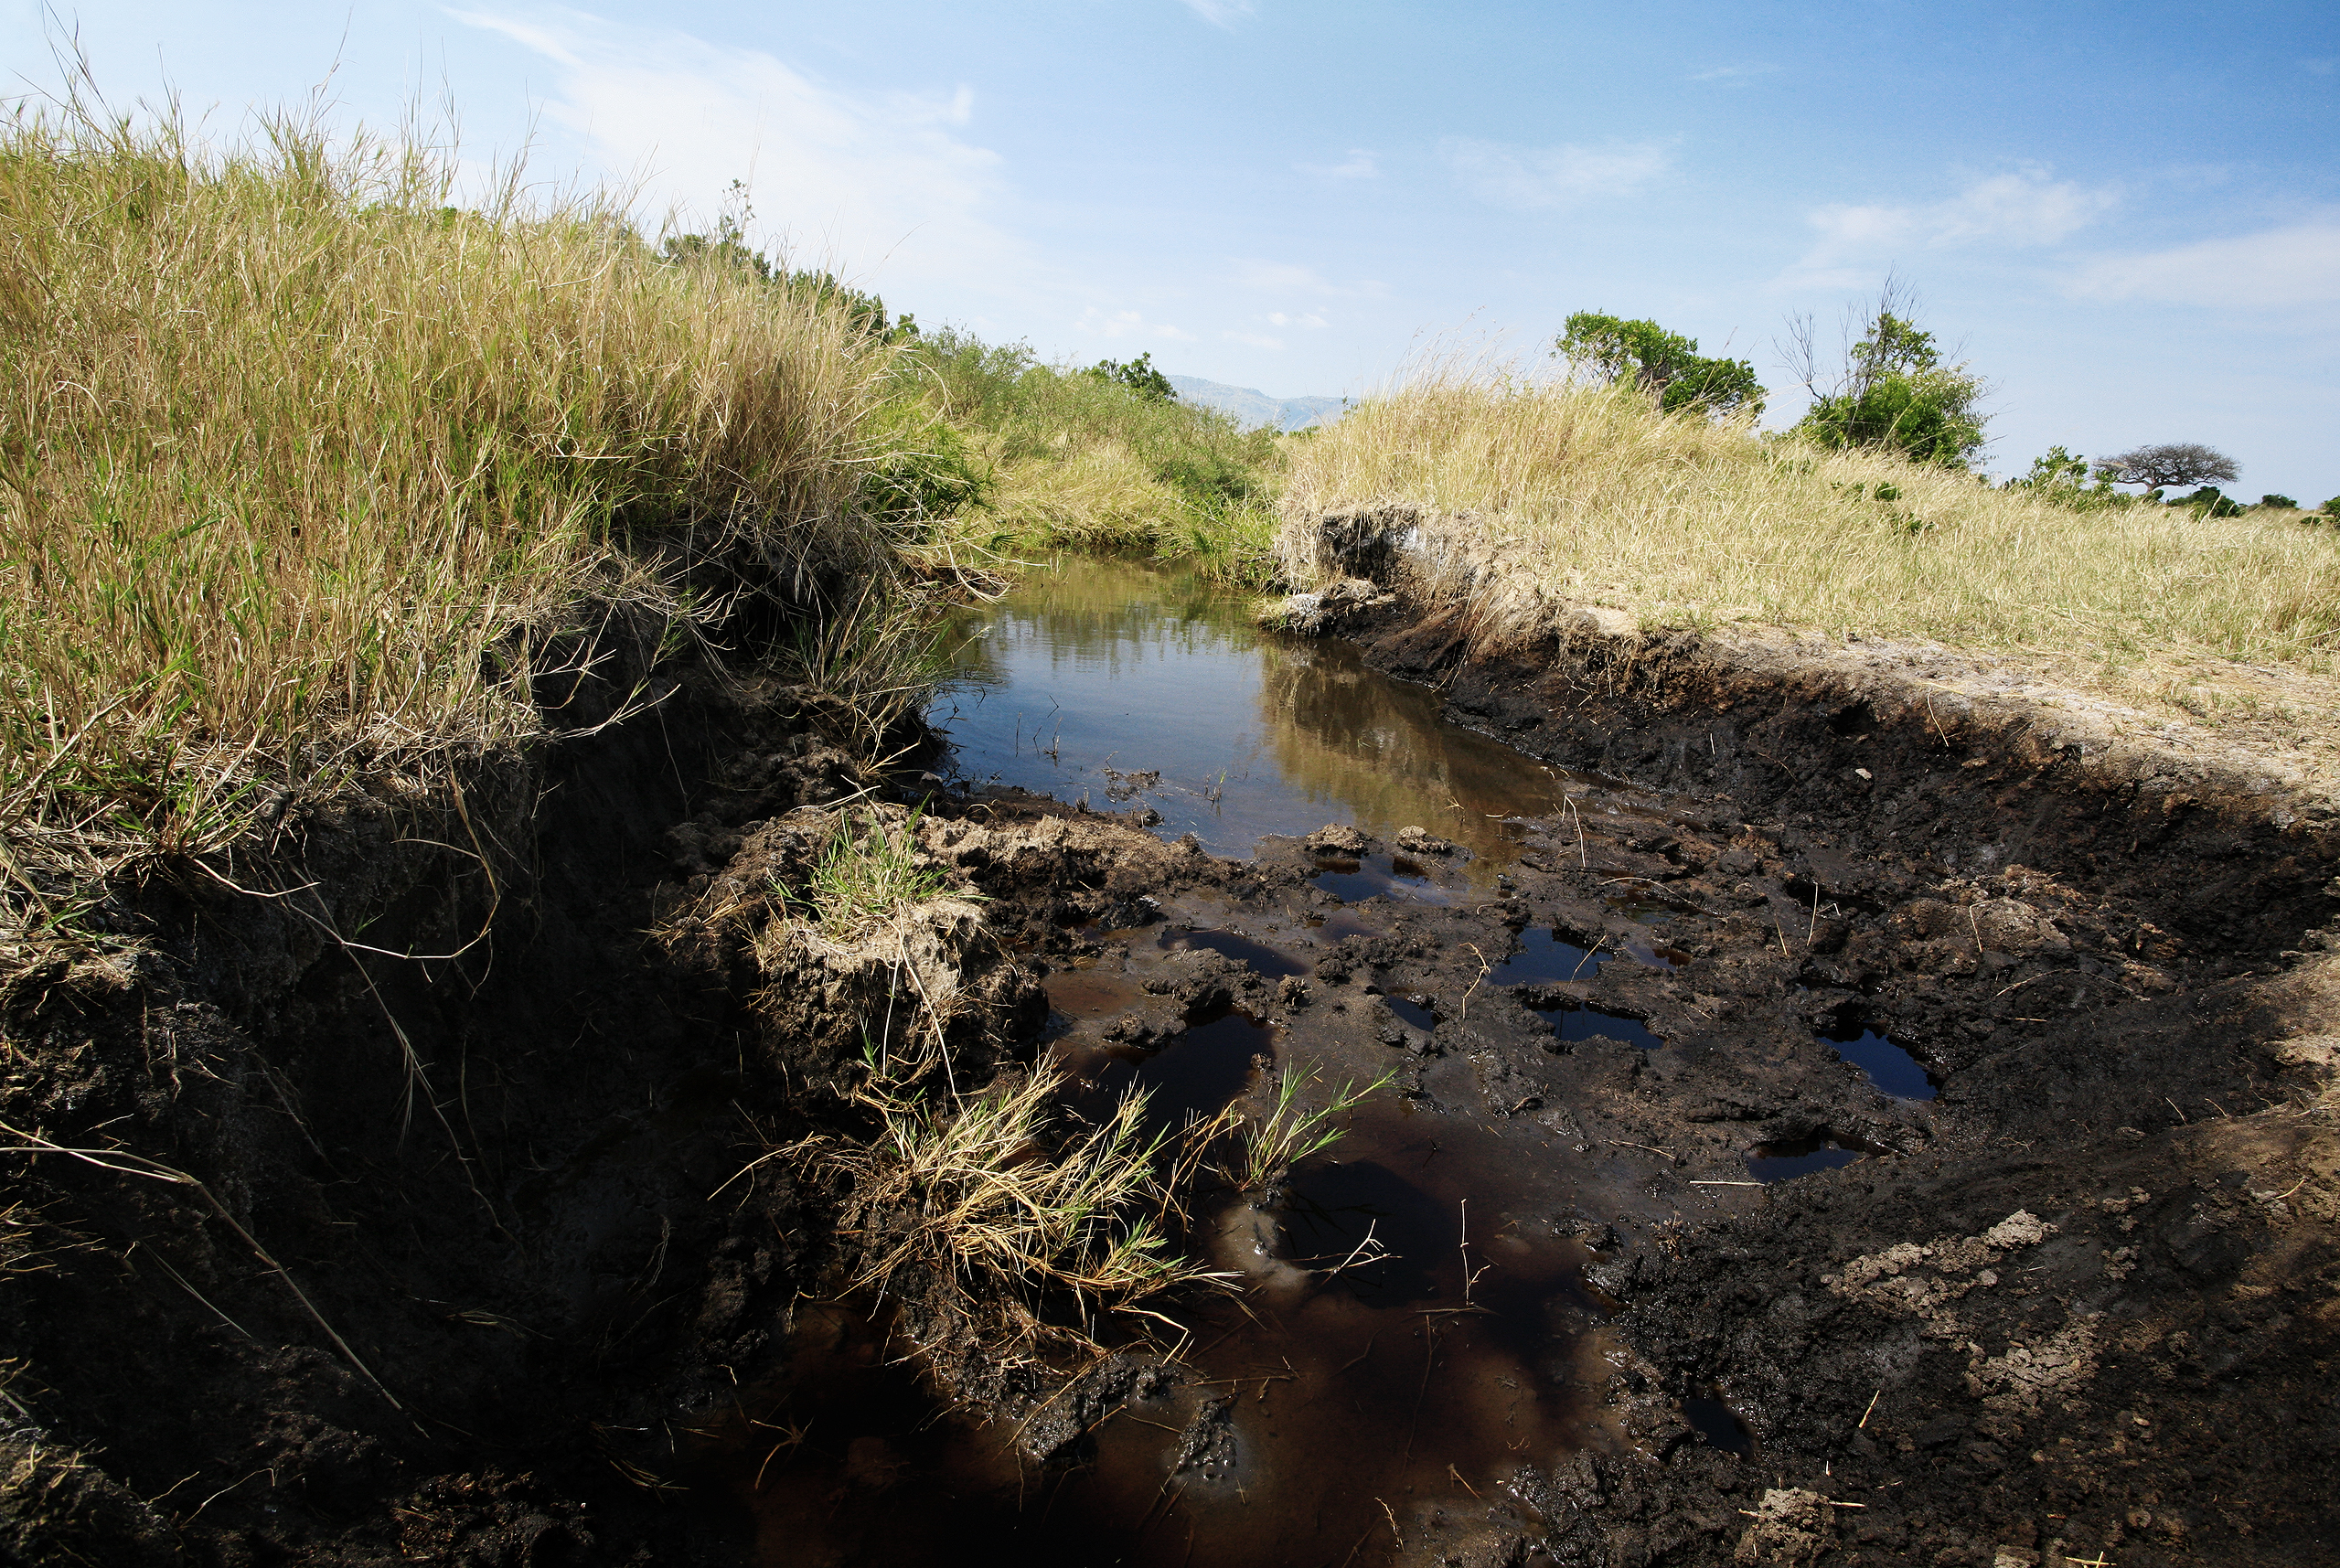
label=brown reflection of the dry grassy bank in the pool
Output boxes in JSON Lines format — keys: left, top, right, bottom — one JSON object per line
{"left": 1259, "top": 641, "right": 1554, "bottom": 849}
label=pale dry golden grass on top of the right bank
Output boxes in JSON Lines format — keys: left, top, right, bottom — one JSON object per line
{"left": 1277, "top": 369, "right": 2340, "bottom": 674}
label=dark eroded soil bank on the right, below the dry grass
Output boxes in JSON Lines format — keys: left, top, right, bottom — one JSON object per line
{"left": 1263, "top": 513, "right": 2340, "bottom": 1563}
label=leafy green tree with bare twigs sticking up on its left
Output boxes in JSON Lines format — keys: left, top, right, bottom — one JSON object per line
{"left": 1790, "top": 279, "right": 1987, "bottom": 468}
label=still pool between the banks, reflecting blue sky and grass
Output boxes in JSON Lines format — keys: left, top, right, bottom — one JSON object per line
{"left": 931, "top": 560, "right": 1558, "bottom": 866}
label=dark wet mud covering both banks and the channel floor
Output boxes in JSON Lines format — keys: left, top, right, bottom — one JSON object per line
{"left": 0, "top": 547, "right": 2340, "bottom": 1568}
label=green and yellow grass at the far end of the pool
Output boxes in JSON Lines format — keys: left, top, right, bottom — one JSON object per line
{"left": 896, "top": 327, "right": 1285, "bottom": 582}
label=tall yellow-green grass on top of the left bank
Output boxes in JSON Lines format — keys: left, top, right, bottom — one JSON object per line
{"left": 0, "top": 103, "right": 903, "bottom": 959}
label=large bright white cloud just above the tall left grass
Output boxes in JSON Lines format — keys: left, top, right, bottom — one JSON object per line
{"left": 452, "top": 9, "right": 1010, "bottom": 281}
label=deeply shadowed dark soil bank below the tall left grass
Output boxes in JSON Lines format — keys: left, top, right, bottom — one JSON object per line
{"left": 0, "top": 641, "right": 940, "bottom": 1563}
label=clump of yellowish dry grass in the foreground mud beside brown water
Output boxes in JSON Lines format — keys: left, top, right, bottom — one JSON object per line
{"left": 794, "top": 1062, "right": 1202, "bottom": 1327}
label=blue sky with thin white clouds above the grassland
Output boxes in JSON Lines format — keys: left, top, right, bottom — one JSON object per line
{"left": 14, "top": 0, "right": 2340, "bottom": 503}
